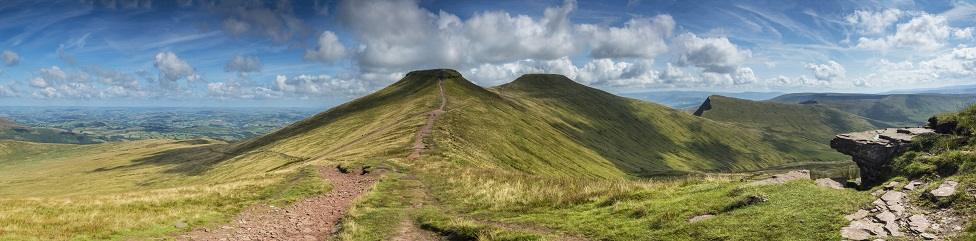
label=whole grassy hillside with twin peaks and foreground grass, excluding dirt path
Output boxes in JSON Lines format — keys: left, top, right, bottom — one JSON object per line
{"left": 0, "top": 70, "right": 888, "bottom": 240}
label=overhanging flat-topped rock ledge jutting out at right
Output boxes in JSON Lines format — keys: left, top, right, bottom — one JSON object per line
{"left": 830, "top": 128, "right": 933, "bottom": 187}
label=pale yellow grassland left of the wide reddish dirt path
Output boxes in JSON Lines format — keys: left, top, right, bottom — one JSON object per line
{"left": 0, "top": 140, "right": 328, "bottom": 240}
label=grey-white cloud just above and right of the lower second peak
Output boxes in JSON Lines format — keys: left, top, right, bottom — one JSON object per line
{"left": 579, "top": 15, "right": 675, "bottom": 59}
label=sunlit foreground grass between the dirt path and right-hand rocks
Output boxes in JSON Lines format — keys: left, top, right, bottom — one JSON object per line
{"left": 416, "top": 164, "right": 873, "bottom": 240}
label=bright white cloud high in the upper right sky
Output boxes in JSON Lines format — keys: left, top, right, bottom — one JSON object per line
{"left": 857, "top": 13, "right": 948, "bottom": 51}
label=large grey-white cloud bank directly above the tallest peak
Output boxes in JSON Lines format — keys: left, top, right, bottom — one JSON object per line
{"left": 338, "top": 0, "right": 580, "bottom": 70}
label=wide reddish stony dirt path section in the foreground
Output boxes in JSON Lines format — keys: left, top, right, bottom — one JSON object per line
{"left": 178, "top": 167, "right": 376, "bottom": 241}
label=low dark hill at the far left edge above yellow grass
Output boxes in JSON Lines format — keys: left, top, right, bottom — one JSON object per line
{"left": 0, "top": 118, "right": 103, "bottom": 144}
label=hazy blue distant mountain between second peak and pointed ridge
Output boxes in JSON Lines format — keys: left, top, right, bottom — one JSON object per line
{"left": 620, "top": 90, "right": 783, "bottom": 109}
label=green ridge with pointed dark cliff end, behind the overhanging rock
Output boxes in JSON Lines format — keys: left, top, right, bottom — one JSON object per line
{"left": 694, "top": 95, "right": 888, "bottom": 147}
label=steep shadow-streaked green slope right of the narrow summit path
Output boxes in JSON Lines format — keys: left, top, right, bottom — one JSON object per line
{"left": 435, "top": 74, "right": 844, "bottom": 177}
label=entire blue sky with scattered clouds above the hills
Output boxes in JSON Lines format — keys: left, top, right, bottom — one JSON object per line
{"left": 0, "top": 0, "right": 976, "bottom": 107}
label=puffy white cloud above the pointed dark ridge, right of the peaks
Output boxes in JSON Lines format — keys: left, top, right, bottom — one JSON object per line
{"left": 672, "top": 33, "right": 752, "bottom": 74}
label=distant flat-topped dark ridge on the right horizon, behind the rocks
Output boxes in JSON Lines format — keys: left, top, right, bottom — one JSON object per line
{"left": 770, "top": 93, "right": 976, "bottom": 126}
